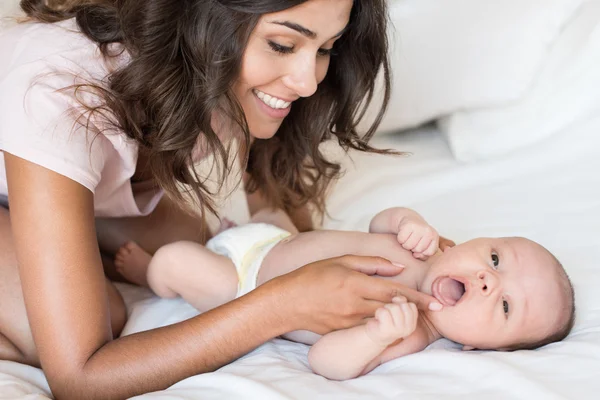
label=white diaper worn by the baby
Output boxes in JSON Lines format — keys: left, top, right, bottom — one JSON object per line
{"left": 206, "top": 224, "right": 290, "bottom": 297}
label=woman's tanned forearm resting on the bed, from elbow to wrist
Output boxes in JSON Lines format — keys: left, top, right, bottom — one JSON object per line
{"left": 65, "top": 290, "right": 292, "bottom": 399}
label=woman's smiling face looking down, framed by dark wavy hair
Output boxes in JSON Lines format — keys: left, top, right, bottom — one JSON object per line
{"left": 234, "top": 0, "right": 352, "bottom": 139}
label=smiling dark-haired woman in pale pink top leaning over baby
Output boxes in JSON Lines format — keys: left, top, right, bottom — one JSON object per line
{"left": 0, "top": 0, "right": 434, "bottom": 399}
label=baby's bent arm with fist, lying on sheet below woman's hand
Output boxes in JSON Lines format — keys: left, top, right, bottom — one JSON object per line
{"left": 308, "top": 297, "right": 426, "bottom": 380}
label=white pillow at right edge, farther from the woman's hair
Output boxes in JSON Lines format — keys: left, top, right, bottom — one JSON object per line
{"left": 439, "top": 0, "right": 600, "bottom": 161}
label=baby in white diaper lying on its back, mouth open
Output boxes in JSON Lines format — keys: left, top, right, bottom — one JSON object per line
{"left": 115, "top": 208, "right": 575, "bottom": 380}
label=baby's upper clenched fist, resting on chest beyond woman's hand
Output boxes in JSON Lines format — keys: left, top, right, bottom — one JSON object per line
{"left": 398, "top": 213, "right": 440, "bottom": 260}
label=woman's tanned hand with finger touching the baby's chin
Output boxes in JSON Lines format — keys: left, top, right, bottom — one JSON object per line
{"left": 259, "top": 256, "right": 442, "bottom": 334}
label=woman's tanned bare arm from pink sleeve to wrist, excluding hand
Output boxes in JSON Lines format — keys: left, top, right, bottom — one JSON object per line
{"left": 5, "top": 154, "right": 296, "bottom": 399}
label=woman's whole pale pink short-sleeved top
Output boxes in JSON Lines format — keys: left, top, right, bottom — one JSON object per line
{"left": 0, "top": 20, "right": 162, "bottom": 217}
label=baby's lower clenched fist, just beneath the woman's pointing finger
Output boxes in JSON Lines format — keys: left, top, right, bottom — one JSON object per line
{"left": 365, "top": 296, "right": 419, "bottom": 346}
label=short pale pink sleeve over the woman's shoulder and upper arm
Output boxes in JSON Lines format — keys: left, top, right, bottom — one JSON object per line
{"left": 0, "top": 62, "right": 110, "bottom": 192}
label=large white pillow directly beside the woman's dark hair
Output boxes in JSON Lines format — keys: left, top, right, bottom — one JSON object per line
{"left": 361, "top": 0, "right": 584, "bottom": 131}
